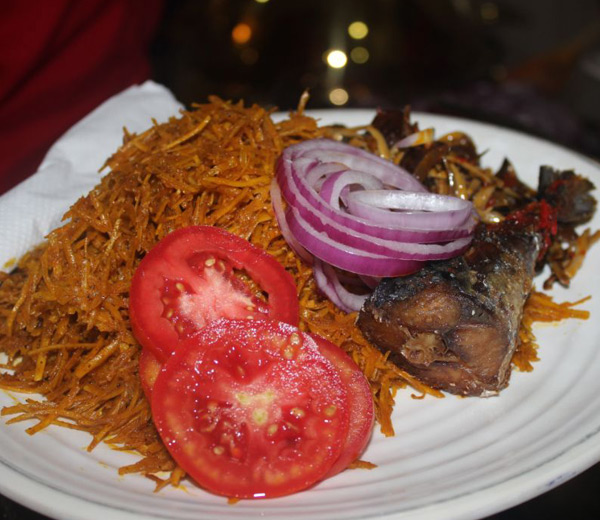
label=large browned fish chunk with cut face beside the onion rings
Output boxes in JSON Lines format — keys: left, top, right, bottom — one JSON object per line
{"left": 358, "top": 213, "right": 547, "bottom": 396}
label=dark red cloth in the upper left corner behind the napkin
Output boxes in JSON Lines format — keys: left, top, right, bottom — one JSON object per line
{"left": 0, "top": 0, "right": 162, "bottom": 193}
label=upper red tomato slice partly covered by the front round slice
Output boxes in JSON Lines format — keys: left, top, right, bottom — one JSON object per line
{"left": 129, "top": 226, "right": 299, "bottom": 361}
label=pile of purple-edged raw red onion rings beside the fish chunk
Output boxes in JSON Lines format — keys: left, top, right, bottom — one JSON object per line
{"left": 271, "top": 134, "right": 476, "bottom": 312}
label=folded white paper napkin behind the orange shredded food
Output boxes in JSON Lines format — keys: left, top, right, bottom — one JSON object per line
{"left": 0, "top": 81, "right": 182, "bottom": 270}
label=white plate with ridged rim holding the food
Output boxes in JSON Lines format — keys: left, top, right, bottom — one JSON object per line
{"left": 0, "top": 106, "right": 600, "bottom": 520}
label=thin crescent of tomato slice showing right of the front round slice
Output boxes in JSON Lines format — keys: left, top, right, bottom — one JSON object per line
{"left": 311, "top": 334, "right": 375, "bottom": 477}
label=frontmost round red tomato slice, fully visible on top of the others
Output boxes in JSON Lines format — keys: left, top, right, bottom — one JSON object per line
{"left": 152, "top": 319, "right": 349, "bottom": 498}
